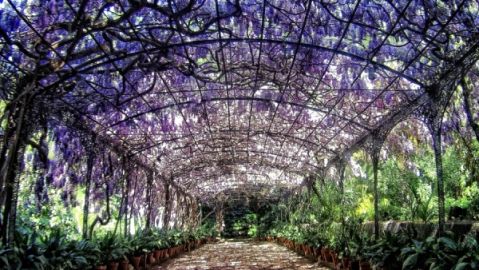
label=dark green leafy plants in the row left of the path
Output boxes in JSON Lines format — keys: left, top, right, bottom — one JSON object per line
{"left": 0, "top": 221, "right": 214, "bottom": 270}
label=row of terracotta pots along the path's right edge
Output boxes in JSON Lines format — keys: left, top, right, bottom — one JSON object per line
{"left": 263, "top": 236, "right": 372, "bottom": 270}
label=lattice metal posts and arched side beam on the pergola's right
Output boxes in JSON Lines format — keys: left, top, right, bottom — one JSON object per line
{"left": 316, "top": 40, "right": 479, "bottom": 237}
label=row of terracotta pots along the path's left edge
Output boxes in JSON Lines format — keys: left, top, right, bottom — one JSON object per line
{"left": 96, "top": 238, "right": 215, "bottom": 270}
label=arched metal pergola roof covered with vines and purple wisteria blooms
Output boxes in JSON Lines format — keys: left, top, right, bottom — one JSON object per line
{"left": 0, "top": 0, "right": 479, "bottom": 243}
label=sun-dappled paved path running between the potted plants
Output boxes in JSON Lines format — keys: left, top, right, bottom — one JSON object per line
{"left": 155, "top": 240, "right": 328, "bottom": 270}
